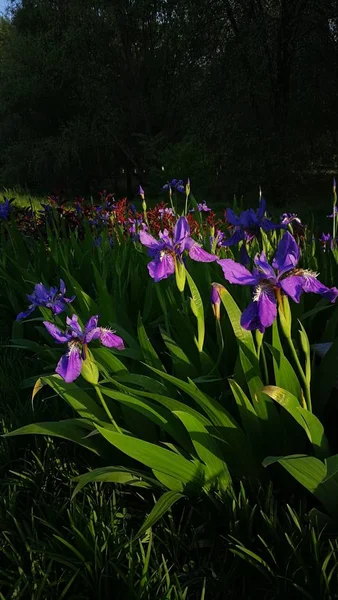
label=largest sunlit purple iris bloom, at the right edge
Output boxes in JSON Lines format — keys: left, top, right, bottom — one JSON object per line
{"left": 218, "top": 232, "right": 338, "bottom": 333}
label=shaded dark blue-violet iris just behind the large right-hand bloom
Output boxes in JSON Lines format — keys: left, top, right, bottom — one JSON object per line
{"left": 223, "top": 198, "right": 286, "bottom": 246}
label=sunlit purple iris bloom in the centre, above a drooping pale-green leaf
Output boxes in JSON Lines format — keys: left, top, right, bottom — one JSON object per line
{"left": 140, "top": 217, "right": 217, "bottom": 282}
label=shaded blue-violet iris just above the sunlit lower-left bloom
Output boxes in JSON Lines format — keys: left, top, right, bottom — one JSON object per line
{"left": 16, "top": 279, "right": 75, "bottom": 321}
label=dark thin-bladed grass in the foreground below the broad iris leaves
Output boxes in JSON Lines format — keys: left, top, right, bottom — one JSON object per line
{"left": 0, "top": 338, "right": 338, "bottom": 600}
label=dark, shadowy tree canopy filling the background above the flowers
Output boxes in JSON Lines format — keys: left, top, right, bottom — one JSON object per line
{"left": 0, "top": 0, "right": 338, "bottom": 199}
